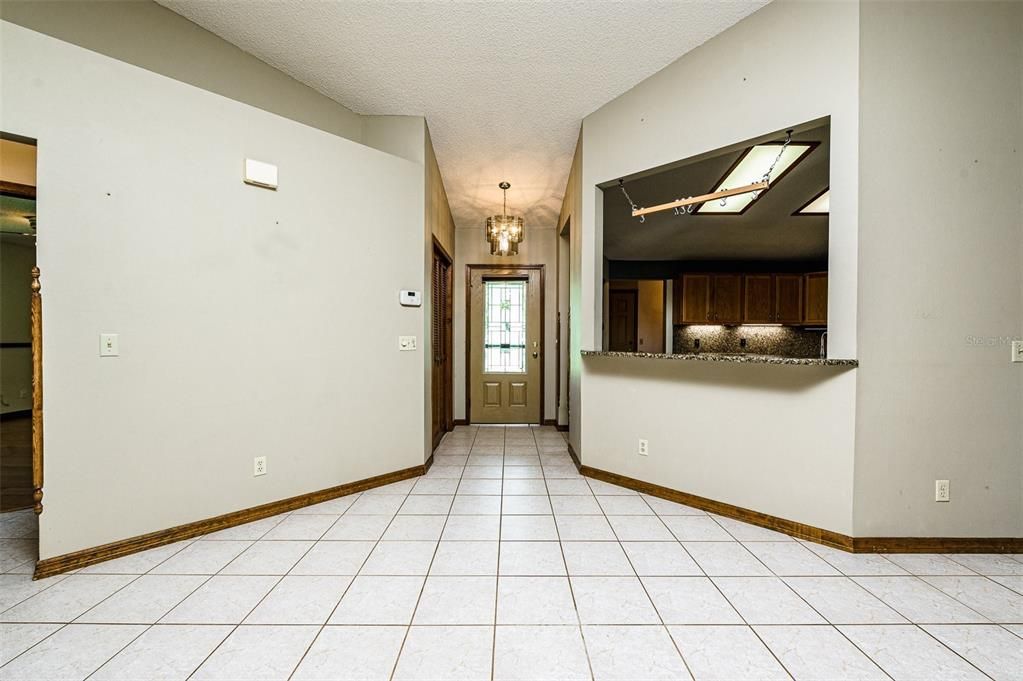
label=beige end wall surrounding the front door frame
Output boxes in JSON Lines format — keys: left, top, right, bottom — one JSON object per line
{"left": 452, "top": 224, "right": 558, "bottom": 419}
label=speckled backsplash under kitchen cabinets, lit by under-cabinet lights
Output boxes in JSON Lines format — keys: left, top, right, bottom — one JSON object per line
{"left": 673, "top": 324, "right": 824, "bottom": 358}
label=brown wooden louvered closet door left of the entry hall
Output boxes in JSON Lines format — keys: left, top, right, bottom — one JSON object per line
{"left": 430, "top": 247, "right": 453, "bottom": 448}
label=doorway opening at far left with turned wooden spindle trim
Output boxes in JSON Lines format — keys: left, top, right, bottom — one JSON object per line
{"left": 0, "top": 133, "right": 42, "bottom": 513}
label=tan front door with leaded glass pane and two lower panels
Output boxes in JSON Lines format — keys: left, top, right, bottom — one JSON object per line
{"left": 469, "top": 268, "right": 543, "bottom": 423}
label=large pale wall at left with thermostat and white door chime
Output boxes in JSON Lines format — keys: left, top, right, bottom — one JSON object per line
{"left": 0, "top": 22, "right": 426, "bottom": 557}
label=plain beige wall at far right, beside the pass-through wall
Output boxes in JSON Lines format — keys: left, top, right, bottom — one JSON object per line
{"left": 855, "top": 2, "right": 1023, "bottom": 537}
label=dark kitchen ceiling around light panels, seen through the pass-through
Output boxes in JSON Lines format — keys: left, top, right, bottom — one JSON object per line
{"left": 604, "top": 125, "right": 831, "bottom": 261}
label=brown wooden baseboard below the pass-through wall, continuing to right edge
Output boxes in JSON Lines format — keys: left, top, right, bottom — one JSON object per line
{"left": 581, "top": 462, "right": 1023, "bottom": 553}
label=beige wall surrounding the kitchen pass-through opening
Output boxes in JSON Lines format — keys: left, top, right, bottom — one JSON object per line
{"left": 571, "top": 2, "right": 859, "bottom": 533}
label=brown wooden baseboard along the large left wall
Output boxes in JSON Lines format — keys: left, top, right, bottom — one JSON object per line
{"left": 33, "top": 455, "right": 433, "bottom": 580}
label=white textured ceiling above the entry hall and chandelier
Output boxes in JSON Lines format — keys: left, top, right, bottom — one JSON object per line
{"left": 158, "top": 0, "right": 767, "bottom": 228}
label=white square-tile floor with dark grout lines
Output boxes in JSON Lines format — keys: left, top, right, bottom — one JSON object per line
{"left": 0, "top": 427, "right": 1023, "bottom": 681}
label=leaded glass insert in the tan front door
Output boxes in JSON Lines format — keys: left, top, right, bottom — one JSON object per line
{"left": 483, "top": 279, "right": 528, "bottom": 373}
